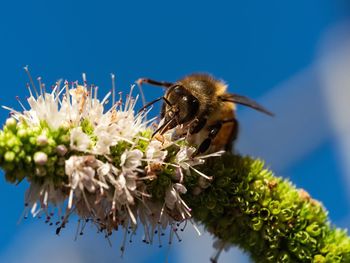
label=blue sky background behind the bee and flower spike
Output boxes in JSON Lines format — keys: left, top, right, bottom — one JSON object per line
{"left": 0, "top": 0, "right": 350, "bottom": 262}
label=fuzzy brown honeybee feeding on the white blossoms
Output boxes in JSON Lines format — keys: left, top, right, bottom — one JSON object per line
{"left": 136, "top": 74, "right": 273, "bottom": 154}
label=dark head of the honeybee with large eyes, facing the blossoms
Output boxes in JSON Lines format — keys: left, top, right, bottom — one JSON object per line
{"left": 162, "top": 84, "right": 199, "bottom": 129}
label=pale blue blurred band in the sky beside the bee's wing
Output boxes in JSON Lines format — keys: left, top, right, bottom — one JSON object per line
{"left": 236, "top": 67, "right": 331, "bottom": 173}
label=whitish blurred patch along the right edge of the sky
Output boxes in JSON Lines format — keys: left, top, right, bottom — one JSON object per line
{"left": 317, "top": 21, "right": 350, "bottom": 205}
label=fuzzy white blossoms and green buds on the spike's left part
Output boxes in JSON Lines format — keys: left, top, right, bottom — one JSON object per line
{"left": 0, "top": 73, "right": 217, "bottom": 251}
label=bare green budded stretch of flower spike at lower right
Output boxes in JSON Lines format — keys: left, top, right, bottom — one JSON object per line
{"left": 184, "top": 154, "right": 350, "bottom": 263}
